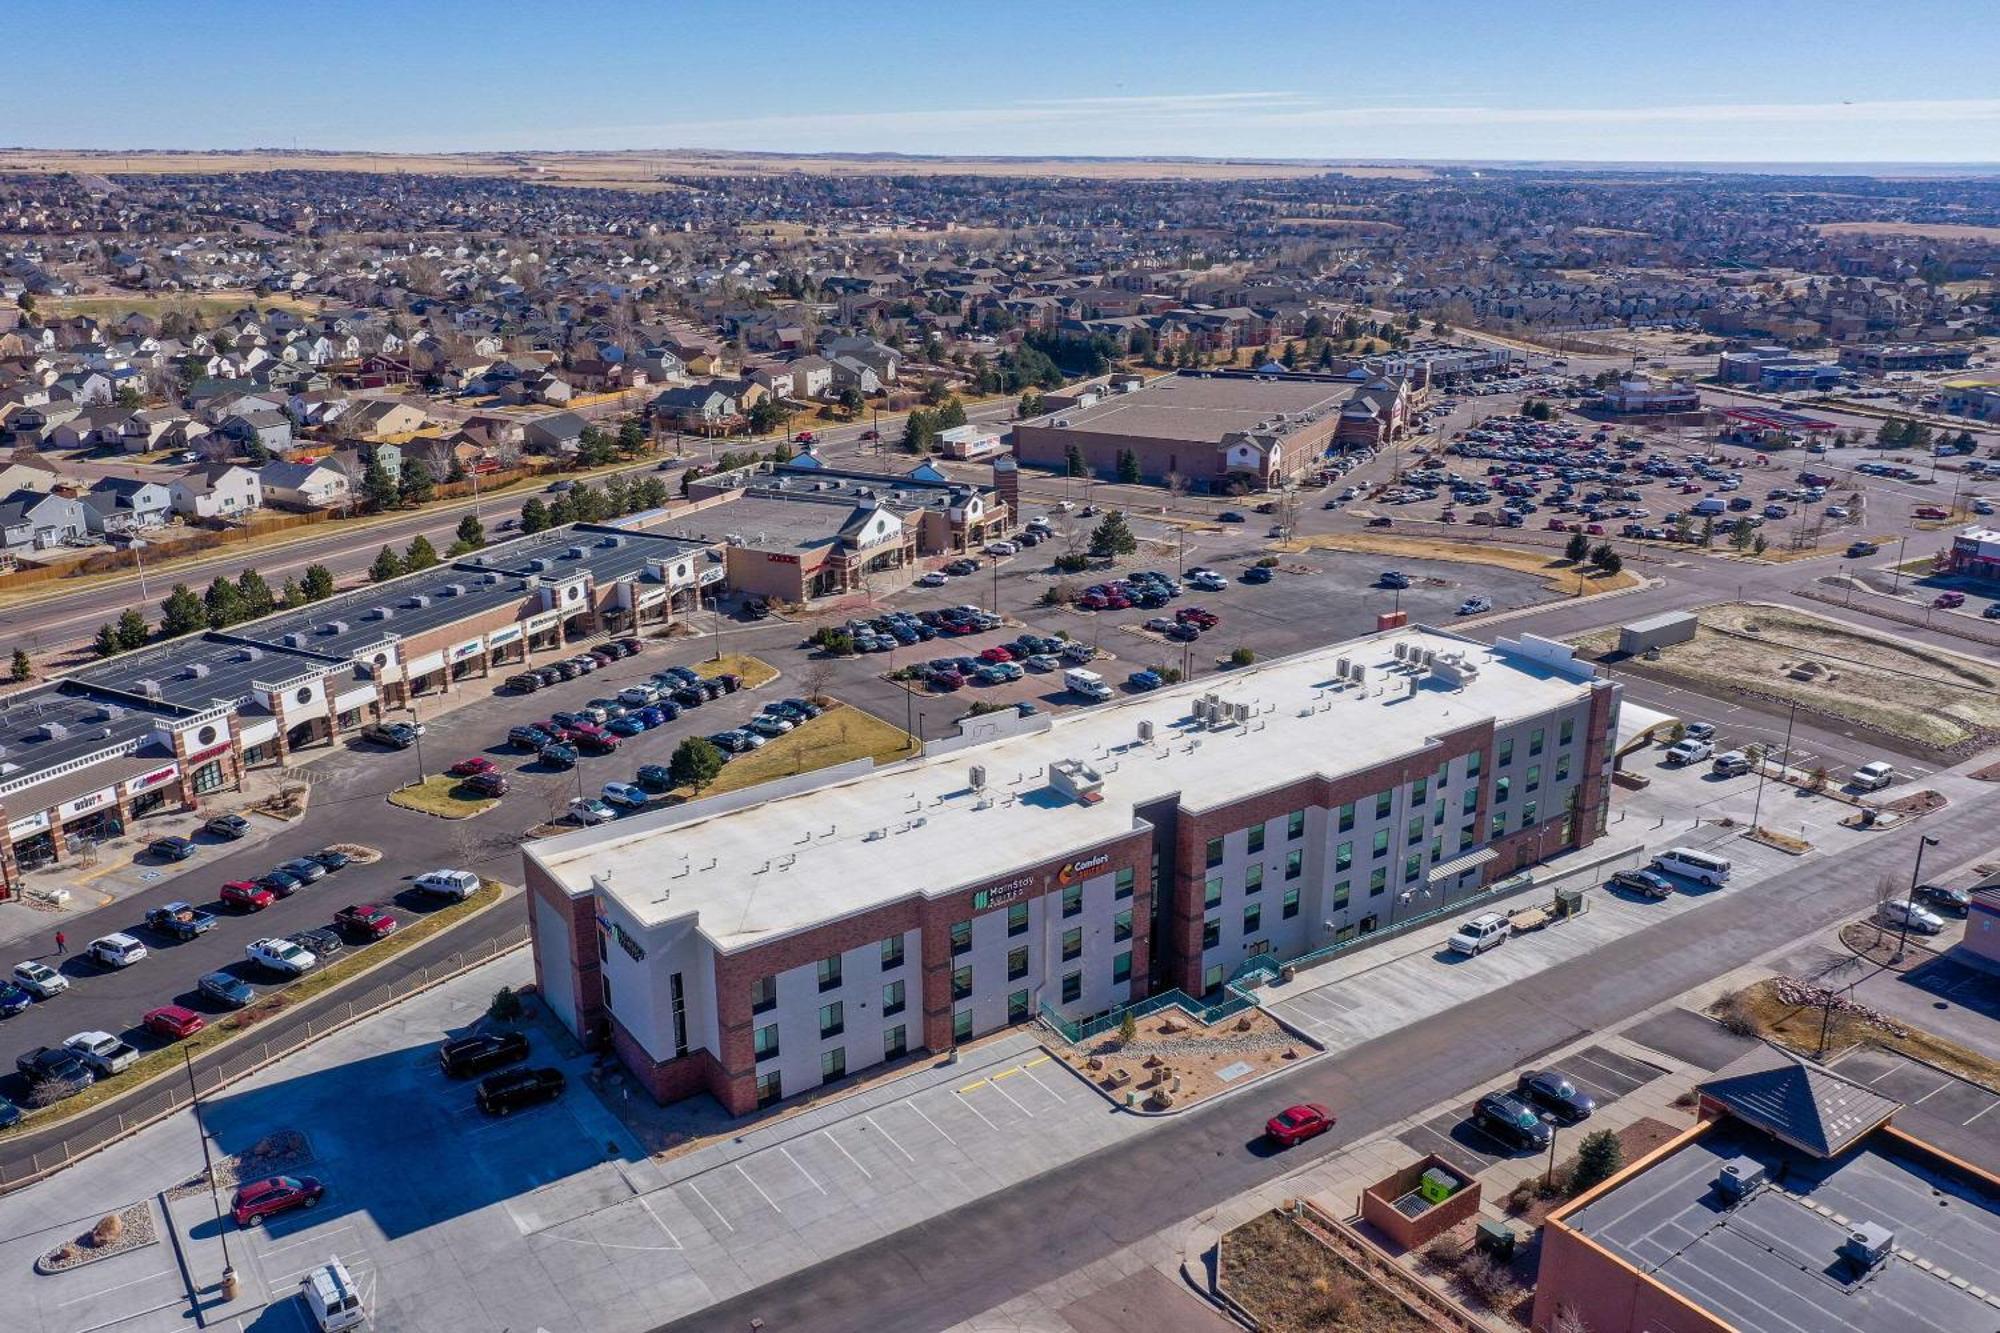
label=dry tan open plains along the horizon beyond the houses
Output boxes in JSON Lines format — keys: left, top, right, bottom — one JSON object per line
{"left": 0, "top": 148, "right": 1434, "bottom": 188}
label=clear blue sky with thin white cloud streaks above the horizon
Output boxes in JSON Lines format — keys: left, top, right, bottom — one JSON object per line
{"left": 15, "top": 0, "right": 2000, "bottom": 162}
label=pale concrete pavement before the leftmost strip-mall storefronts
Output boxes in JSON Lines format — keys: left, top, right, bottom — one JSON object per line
{"left": 0, "top": 769, "right": 310, "bottom": 955}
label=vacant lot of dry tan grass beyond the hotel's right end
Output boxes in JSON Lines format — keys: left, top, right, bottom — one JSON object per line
{"left": 1576, "top": 604, "right": 2000, "bottom": 751}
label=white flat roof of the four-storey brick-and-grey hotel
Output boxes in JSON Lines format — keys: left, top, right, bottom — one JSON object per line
{"left": 522, "top": 626, "right": 1594, "bottom": 953}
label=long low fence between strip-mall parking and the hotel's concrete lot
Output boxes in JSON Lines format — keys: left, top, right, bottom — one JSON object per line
{"left": 0, "top": 925, "right": 528, "bottom": 1193}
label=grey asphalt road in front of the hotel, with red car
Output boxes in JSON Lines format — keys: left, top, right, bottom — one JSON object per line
{"left": 662, "top": 784, "right": 1990, "bottom": 1333}
